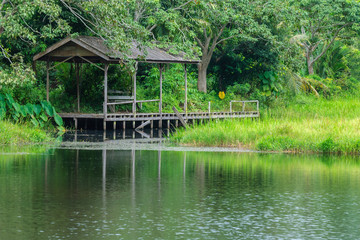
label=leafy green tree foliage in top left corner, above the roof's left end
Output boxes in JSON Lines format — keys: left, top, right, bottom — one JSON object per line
{"left": 0, "top": 0, "right": 70, "bottom": 62}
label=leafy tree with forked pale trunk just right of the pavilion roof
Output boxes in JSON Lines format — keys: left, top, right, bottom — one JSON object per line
{"left": 174, "top": 0, "right": 268, "bottom": 92}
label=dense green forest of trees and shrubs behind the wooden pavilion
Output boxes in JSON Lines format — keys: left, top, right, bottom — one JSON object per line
{"left": 0, "top": 0, "right": 360, "bottom": 142}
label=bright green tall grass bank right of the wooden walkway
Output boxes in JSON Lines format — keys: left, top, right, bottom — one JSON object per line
{"left": 172, "top": 97, "right": 360, "bottom": 153}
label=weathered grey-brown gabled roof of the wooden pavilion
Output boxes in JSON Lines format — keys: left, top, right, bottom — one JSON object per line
{"left": 33, "top": 36, "right": 200, "bottom": 64}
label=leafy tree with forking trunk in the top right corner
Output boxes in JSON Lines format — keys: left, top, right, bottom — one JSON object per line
{"left": 289, "top": 0, "right": 360, "bottom": 74}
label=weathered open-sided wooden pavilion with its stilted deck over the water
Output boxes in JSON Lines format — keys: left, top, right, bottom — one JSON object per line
{"left": 33, "top": 36, "right": 259, "bottom": 130}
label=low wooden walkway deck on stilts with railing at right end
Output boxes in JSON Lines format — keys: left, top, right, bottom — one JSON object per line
{"left": 59, "top": 100, "right": 260, "bottom": 130}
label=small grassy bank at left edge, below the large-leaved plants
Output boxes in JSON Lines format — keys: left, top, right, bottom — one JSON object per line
{"left": 0, "top": 121, "right": 52, "bottom": 145}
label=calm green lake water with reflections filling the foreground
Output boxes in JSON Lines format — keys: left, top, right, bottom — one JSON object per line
{"left": 0, "top": 143, "right": 360, "bottom": 239}
